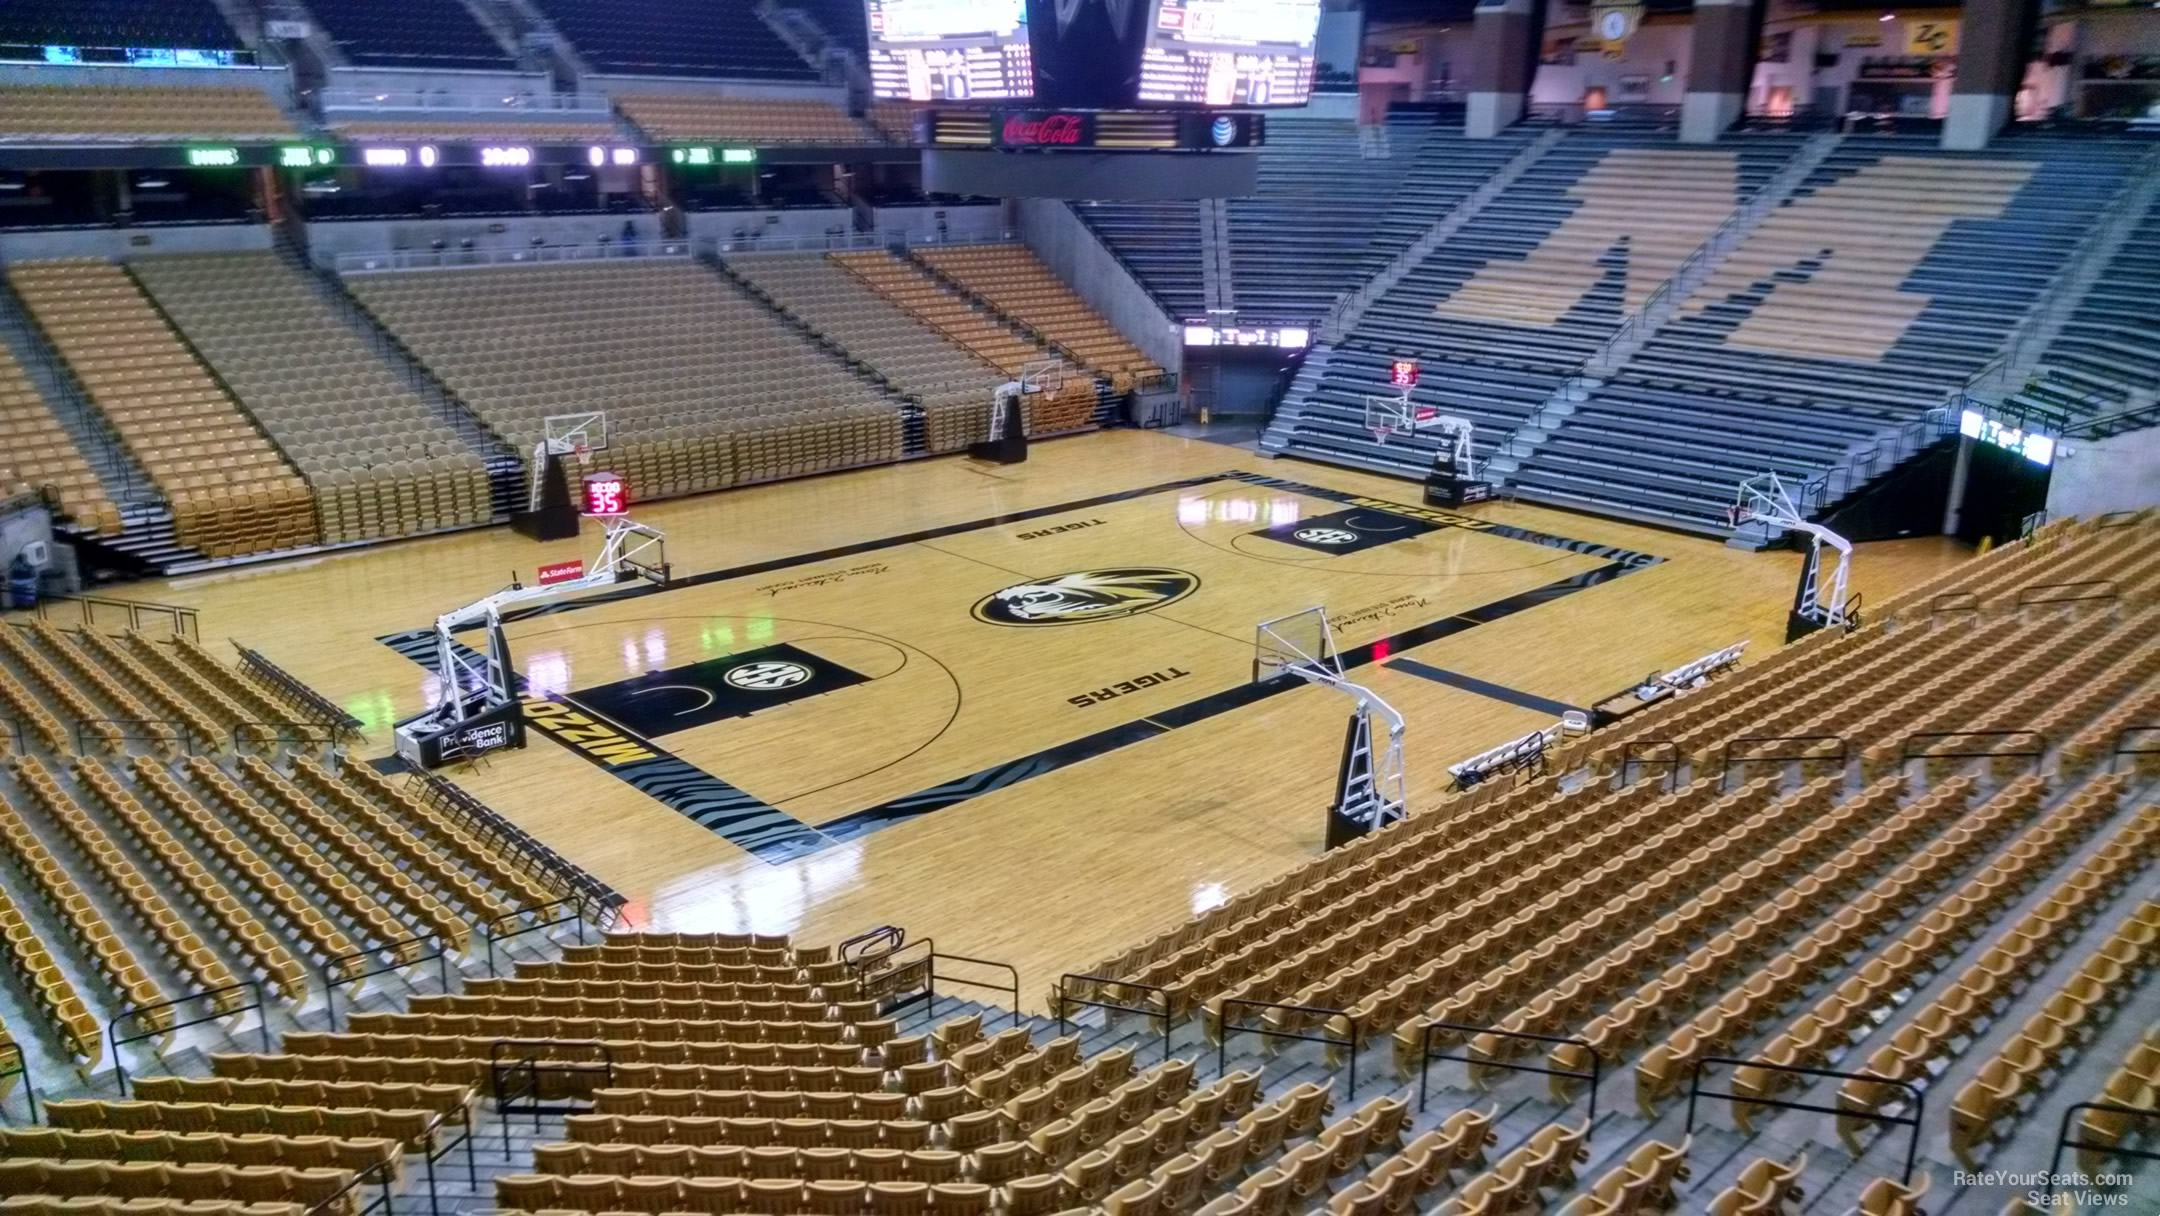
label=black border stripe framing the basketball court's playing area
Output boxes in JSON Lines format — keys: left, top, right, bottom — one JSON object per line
{"left": 378, "top": 469, "right": 1663, "bottom": 864}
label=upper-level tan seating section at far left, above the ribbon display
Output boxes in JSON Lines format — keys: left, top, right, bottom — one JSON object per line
{"left": 0, "top": 84, "right": 300, "bottom": 143}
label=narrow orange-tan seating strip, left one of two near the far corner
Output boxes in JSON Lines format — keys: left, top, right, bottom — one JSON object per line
{"left": 832, "top": 251, "right": 1102, "bottom": 434}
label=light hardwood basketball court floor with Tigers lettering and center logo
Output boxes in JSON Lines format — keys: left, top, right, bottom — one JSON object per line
{"left": 138, "top": 432, "right": 1959, "bottom": 1004}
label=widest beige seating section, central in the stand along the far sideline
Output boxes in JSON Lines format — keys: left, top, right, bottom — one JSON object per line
{"left": 348, "top": 257, "right": 903, "bottom": 499}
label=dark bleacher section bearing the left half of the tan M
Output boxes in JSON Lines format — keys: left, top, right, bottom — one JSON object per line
{"left": 1287, "top": 130, "right": 1797, "bottom": 473}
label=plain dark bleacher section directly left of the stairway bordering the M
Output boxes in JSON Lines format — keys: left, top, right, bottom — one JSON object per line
{"left": 1229, "top": 114, "right": 1434, "bottom": 326}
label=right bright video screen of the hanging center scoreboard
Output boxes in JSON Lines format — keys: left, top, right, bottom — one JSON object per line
{"left": 1138, "top": 0, "right": 1320, "bottom": 106}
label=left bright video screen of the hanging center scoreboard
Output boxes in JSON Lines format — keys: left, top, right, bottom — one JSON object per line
{"left": 866, "top": 0, "right": 1035, "bottom": 102}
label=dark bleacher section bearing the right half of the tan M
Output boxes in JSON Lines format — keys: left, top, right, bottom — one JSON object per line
{"left": 1516, "top": 136, "right": 2134, "bottom": 531}
